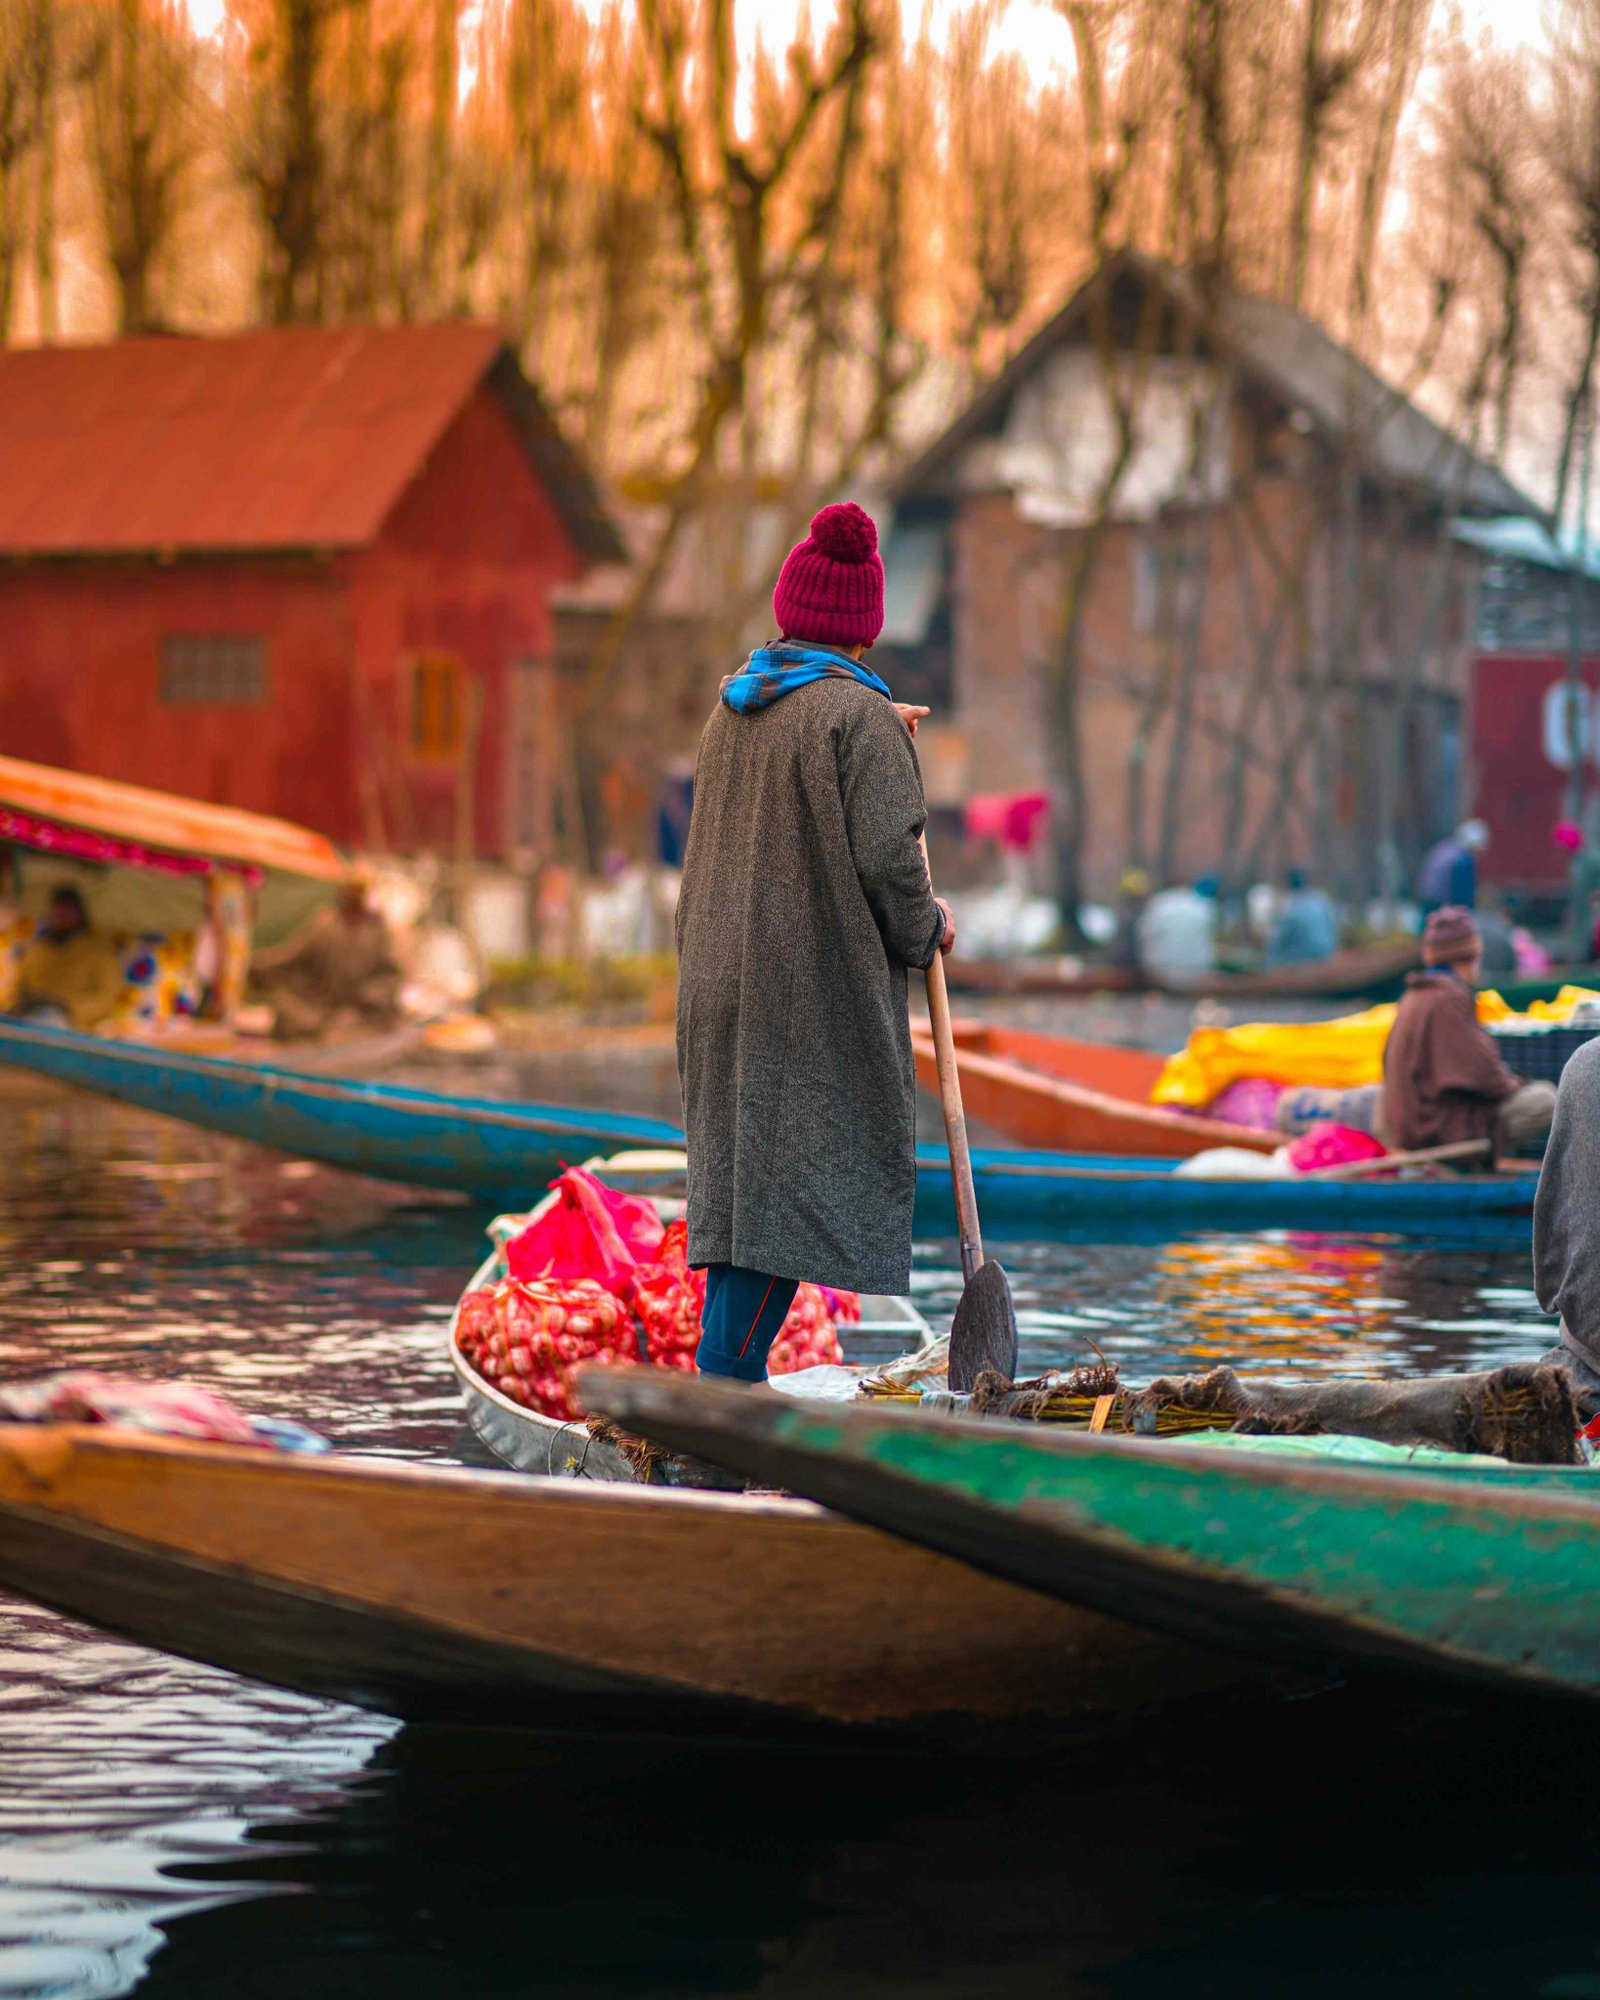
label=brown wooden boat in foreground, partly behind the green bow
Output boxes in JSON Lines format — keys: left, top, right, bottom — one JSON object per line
{"left": 0, "top": 1424, "right": 1254, "bottom": 1740}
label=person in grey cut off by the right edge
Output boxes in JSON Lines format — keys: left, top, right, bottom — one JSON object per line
{"left": 1534, "top": 1040, "right": 1600, "bottom": 1420}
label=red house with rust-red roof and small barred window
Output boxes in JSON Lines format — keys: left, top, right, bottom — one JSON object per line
{"left": 0, "top": 324, "right": 622, "bottom": 856}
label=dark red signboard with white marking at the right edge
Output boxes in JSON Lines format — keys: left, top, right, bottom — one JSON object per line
{"left": 1468, "top": 652, "right": 1600, "bottom": 888}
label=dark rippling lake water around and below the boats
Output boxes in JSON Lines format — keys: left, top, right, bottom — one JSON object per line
{"left": 0, "top": 1066, "right": 1600, "bottom": 2000}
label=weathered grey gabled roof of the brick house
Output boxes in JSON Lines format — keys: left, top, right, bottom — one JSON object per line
{"left": 894, "top": 250, "right": 1540, "bottom": 514}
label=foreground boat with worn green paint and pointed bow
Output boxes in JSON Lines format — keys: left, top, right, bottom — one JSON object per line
{"left": 592, "top": 1368, "right": 1600, "bottom": 1698}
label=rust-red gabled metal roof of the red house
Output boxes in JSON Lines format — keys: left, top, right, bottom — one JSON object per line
{"left": 0, "top": 322, "right": 622, "bottom": 562}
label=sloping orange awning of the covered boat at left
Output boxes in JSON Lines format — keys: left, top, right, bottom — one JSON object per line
{"left": 0, "top": 756, "right": 348, "bottom": 882}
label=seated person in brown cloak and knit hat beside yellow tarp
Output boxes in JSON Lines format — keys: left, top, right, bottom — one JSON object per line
{"left": 1378, "top": 904, "right": 1556, "bottom": 1156}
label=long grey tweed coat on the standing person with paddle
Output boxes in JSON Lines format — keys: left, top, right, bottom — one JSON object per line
{"left": 678, "top": 678, "right": 942, "bottom": 1292}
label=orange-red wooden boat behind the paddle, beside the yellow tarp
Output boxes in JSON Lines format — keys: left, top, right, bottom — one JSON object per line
{"left": 912, "top": 1020, "right": 1282, "bottom": 1160}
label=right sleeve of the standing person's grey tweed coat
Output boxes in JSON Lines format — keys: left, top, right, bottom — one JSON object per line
{"left": 838, "top": 698, "right": 944, "bottom": 966}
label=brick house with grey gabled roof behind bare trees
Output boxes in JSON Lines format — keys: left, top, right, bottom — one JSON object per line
{"left": 878, "top": 252, "right": 1532, "bottom": 894}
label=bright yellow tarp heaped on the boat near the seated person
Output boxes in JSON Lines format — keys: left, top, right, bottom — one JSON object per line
{"left": 1150, "top": 986, "right": 1600, "bottom": 1112}
